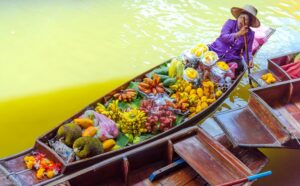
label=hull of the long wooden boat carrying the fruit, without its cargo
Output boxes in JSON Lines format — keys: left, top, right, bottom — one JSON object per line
{"left": 0, "top": 60, "right": 245, "bottom": 185}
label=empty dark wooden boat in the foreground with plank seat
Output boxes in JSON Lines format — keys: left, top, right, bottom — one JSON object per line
{"left": 49, "top": 122, "right": 268, "bottom": 186}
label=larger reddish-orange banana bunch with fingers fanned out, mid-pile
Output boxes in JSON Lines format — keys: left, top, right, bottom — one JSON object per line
{"left": 138, "top": 74, "right": 165, "bottom": 95}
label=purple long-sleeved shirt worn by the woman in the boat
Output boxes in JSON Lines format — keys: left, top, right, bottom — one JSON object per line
{"left": 209, "top": 19, "right": 254, "bottom": 62}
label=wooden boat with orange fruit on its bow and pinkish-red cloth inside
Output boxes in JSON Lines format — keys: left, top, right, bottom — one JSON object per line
{"left": 249, "top": 52, "right": 300, "bottom": 86}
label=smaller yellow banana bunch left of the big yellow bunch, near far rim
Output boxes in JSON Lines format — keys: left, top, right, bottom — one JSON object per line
{"left": 95, "top": 100, "right": 121, "bottom": 122}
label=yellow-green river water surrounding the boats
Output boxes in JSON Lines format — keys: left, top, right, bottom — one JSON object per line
{"left": 0, "top": 0, "right": 300, "bottom": 185}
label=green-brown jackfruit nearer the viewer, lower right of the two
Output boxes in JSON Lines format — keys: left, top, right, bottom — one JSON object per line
{"left": 73, "top": 136, "right": 103, "bottom": 159}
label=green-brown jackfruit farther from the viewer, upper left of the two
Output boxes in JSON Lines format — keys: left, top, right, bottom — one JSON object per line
{"left": 56, "top": 123, "right": 81, "bottom": 147}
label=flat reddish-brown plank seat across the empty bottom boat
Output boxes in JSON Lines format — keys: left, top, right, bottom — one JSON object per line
{"left": 174, "top": 130, "right": 251, "bottom": 185}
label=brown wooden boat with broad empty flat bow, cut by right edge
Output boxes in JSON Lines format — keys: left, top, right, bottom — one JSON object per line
{"left": 214, "top": 79, "right": 300, "bottom": 149}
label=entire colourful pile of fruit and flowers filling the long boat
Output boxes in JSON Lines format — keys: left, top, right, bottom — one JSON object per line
{"left": 49, "top": 44, "right": 234, "bottom": 162}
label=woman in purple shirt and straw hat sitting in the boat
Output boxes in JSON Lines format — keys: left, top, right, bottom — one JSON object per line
{"left": 209, "top": 5, "right": 260, "bottom": 71}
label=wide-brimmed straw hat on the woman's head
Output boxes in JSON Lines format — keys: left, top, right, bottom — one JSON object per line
{"left": 231, "top": 5, "right": 260, "bottom": 28}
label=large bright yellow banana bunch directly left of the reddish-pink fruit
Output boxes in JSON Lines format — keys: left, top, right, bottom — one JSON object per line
{"left": 119, "top": 109, "right": 147, "bottom": 136}
